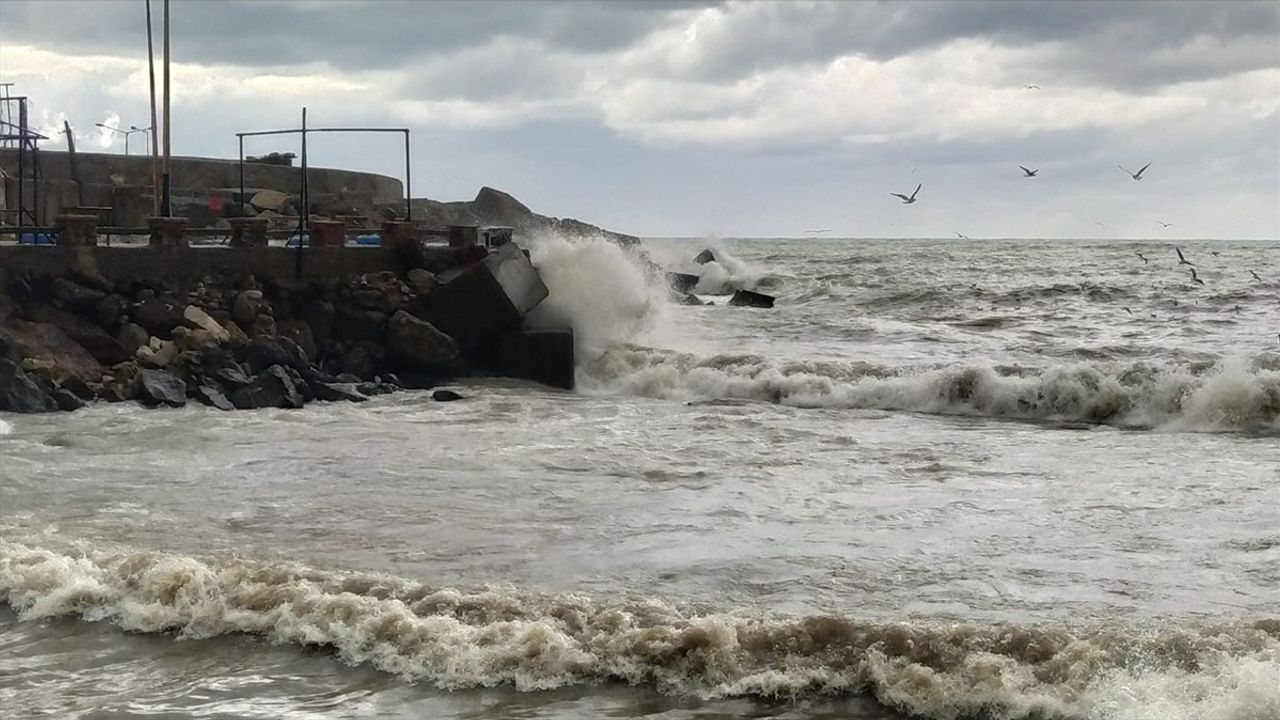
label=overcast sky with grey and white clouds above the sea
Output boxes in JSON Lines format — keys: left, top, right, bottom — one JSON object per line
{"left": 0, "top": 0, "right": 1280, "bottom": 238}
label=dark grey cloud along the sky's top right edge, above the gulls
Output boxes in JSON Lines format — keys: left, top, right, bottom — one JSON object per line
{"left": 650, "top": 1, "right": 1280, "bottom": 88}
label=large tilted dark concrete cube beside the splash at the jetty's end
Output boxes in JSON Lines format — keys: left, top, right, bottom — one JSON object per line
{"left": 428, "top": 243, "right": 548, "bottom": 351}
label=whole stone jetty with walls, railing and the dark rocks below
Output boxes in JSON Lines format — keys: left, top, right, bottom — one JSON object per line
{"left": 0, "top": 151, "right": 624, "bottom": 413}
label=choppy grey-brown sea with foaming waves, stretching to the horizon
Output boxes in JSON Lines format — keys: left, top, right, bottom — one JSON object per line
{"left": 0, "top": 233, "right": 1280, "bottom": 720}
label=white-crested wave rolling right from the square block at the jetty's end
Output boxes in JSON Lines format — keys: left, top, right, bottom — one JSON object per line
{"left": 580, "top": 345, "right": 1280, "bottom": 433}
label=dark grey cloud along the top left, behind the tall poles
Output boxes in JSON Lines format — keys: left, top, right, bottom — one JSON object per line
{"left": 0, "top": 0, "right": 701, "bottom": 70}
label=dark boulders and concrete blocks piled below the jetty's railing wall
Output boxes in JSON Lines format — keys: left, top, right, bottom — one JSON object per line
{"left": 0, "top": 238, "right": 573, "bottom": 413}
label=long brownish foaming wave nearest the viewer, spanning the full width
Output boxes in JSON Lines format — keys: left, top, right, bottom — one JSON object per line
{"left": 0, "top": 541, "right": 1280, "bottom": 720}
